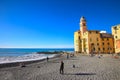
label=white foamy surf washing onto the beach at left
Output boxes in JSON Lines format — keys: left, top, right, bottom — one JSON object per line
{"left": 0, "top": 53, "right": 56, "bottom": 64}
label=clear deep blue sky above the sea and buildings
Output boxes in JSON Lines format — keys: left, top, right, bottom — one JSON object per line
{"left": 0, "top": 0, "right": 120, "bottom": 48}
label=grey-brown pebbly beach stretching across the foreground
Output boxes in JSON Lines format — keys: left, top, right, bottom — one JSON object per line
{"left": 0, "top": 55, "right": 120, "bottom": 80}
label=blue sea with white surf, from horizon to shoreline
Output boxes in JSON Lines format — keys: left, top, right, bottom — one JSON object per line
{"left": 0, "top": 48, "right": 74, "bottom": 64}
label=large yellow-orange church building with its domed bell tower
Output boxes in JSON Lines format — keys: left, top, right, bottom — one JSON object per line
{"left": 74, "top": 17, "right": 114, "bottom": 54}
